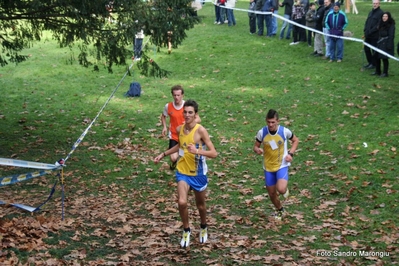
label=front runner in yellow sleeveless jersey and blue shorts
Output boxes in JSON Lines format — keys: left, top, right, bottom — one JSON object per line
{"left": 154, "top": 100, "right": 217, "bottom": 248}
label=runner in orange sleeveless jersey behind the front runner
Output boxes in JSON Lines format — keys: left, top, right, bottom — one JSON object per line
{"left": 161, "top": 85, "right": 201, "bottom": 170}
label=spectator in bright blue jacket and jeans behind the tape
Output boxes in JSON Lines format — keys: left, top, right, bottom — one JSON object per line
{"left": 326, "top": 2, "right": 348, "bottom": 63}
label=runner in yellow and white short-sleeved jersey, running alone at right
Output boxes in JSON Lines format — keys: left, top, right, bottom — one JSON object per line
{"left": 254, "top": 109, "right": 299, "bottom": 220}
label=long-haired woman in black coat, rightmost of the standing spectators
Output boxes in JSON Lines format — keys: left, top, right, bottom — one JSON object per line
{"left": 371, "top": 12, "right": 395, "bottom": 78}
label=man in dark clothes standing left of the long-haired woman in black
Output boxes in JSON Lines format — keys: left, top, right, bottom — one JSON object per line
{"left": 363, "top": 0, "right": 384, "bottom": 69}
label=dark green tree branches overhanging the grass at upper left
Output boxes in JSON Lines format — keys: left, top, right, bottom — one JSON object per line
{"left": 0, "top": 0, "right": 199, "bottom": 77}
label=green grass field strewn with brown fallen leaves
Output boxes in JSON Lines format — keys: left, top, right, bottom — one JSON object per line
{"left": 0, "top": 1, "right": 399, "bottom": 265}
